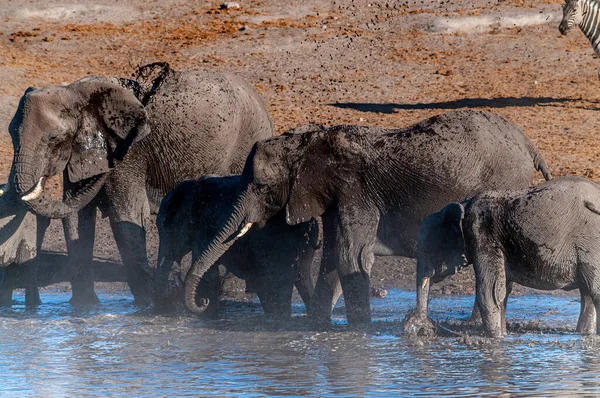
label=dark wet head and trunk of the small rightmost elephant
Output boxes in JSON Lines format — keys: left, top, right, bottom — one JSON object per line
{"left": 417, "top": 203, "right": 467, "bottom": 316}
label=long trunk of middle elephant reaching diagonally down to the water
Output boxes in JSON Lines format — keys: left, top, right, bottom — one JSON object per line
{"left": 184, "top": 191, "right": 252, "bottom": 314}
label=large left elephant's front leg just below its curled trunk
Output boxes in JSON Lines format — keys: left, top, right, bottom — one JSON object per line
{"left": 63, "top": 202, "right": 100, "bottom": 306}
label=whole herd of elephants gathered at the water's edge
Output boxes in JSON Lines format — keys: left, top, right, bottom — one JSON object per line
{"left": 0, "top": 64, "right": 600, "bottom": 336}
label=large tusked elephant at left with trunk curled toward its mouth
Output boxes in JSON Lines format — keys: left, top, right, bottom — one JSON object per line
{"left": 9, "top": 70, "right": 273, "bottom": 304}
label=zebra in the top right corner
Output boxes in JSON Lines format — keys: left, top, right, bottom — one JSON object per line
{"left": 558, "top": 0, "right": 600, "bottom": 79}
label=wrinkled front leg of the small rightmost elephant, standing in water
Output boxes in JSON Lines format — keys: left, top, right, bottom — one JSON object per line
{"left": 473, "top": 249, "right": 507, "bottom": 337}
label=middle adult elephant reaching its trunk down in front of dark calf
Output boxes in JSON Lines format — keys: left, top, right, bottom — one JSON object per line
{"left": 185, "top": 111, "right": 549, "bottom": 324}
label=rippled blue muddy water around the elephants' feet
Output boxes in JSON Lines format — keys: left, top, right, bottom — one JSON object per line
{"left": 0, "top": 290, "right": 600, "bottom": 397}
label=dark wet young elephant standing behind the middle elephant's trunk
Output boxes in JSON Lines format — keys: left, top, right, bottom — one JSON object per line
{"left": 154, "top": 175, "right": 319, "bottom": 319}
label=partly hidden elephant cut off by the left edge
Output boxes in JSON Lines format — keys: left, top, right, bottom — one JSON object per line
{"left": 0, "top": 184, "right": 50, "bottom": 307}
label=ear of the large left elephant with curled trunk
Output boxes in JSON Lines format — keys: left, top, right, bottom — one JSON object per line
{"left": 68, "top": 79, "right": 150, "bottom": 182}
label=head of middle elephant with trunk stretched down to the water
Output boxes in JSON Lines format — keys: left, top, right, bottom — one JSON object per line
{"left": 185, "top": 126, "right": 369, "bottom": 312}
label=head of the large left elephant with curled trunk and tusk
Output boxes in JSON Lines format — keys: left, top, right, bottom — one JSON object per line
{"left": 5, "top": 77, "right": 150, "bottom": 218}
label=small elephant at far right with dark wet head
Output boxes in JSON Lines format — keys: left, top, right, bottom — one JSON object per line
{"left": 417, "top": 177, "right": 600, "bottom": 337}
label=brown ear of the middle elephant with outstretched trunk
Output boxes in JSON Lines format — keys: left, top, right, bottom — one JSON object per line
{"left": 286, "top": 128, "right": 368, "bottom": 225}
